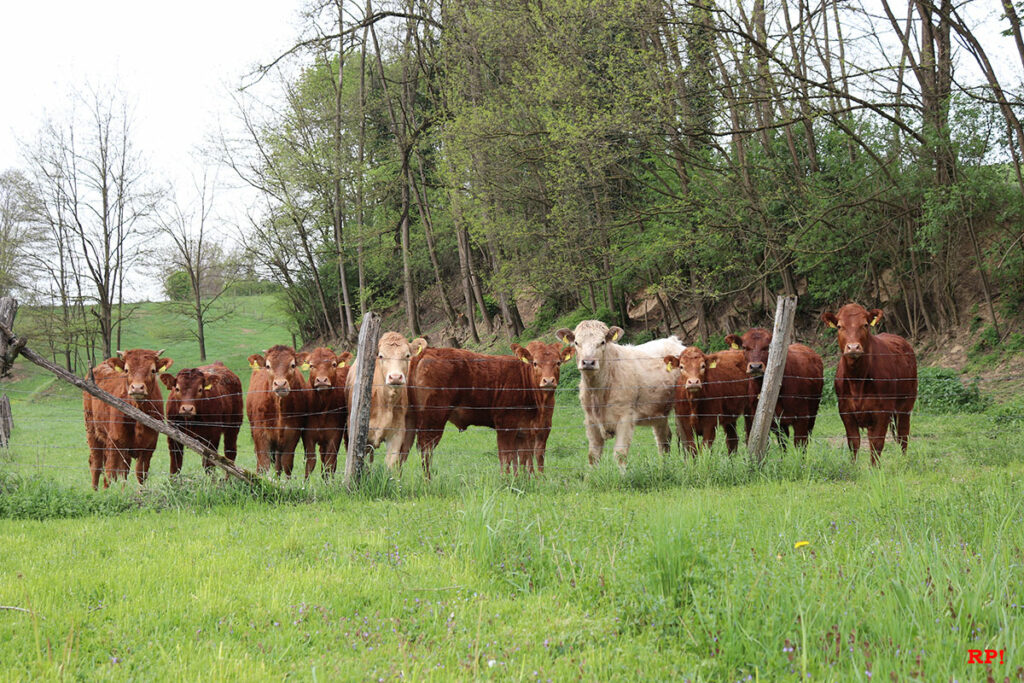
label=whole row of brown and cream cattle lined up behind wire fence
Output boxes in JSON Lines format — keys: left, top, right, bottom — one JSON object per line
{"left": 84, "top": 304, "right": 918, "bottom": 488}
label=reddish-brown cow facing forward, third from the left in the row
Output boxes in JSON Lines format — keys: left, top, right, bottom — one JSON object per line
{"left": 246, "top": 344, "right": 309, "bottom": 476}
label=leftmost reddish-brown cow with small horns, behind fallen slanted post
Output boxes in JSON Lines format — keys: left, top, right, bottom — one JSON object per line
{"left": 82, "top": 348, "right": 174, "bottom": 488}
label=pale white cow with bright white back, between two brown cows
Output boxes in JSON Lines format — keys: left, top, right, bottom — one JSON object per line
{"left": 555, "top": 321, "right": 686, "bottom": 471}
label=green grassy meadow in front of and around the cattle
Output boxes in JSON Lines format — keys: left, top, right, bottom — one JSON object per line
{"left": 0, "top": 299, "right": 1024, "bottom": 681}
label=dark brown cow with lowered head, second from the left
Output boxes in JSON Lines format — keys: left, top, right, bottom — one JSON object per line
{"left": 160, "top": 360, "right": 242, "bottom": 476}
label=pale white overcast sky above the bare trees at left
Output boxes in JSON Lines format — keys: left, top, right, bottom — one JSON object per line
{"left": 0, "top": 0, "right": 302, "bottom": 177}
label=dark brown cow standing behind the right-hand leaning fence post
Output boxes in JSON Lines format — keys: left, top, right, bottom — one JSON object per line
{"left": 725, "top": 328, "right": 825, "bottom": 447}
